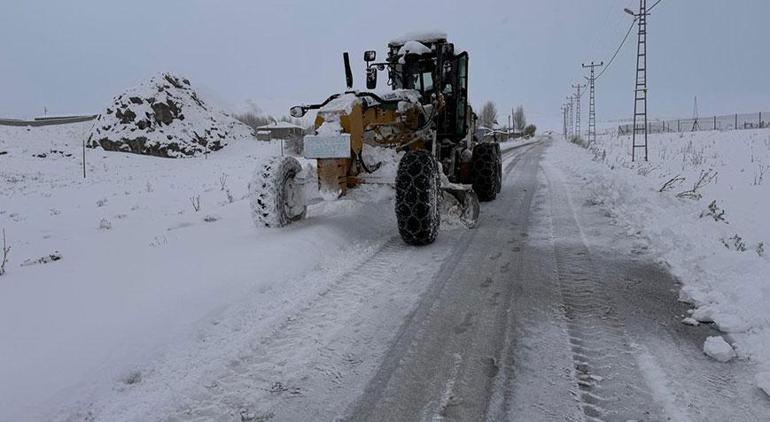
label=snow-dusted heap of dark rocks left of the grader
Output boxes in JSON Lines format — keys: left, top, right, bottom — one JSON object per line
{"left": 88, "top": 73, "right": 253, "bottom": 158}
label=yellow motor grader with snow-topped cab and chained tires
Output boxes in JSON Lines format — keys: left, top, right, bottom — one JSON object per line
{"left": 249, "top": 34, "right": 501, "bottom": 245}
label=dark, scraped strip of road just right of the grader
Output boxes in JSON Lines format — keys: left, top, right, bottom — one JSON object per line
{"left": 347, "top": 140, "right": 539, "bottom": 421}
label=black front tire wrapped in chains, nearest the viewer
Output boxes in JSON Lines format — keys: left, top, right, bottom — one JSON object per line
{"left": 396, "top": 151, "right": 441, "bottom": 246}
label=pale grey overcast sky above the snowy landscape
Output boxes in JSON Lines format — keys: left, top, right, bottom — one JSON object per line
{"left": 0, "top": 0, "right": 770, "bottom": 128}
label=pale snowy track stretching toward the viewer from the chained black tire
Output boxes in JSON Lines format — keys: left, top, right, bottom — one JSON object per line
{"left": 157, "top": 233, "right": 462, "bottom": 420}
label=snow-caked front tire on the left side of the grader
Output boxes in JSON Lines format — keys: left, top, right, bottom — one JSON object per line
{"left": 249, "top": 156, "right": 307, "bottom": 227}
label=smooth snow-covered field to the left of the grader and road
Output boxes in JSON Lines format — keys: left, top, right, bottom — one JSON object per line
{"left": 0, "top": 122, "right": 404, "bottom": 421}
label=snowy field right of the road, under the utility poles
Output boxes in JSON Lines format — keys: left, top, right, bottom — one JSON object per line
{"left": 547, "top": 130, "right": 770, "bottom": 392}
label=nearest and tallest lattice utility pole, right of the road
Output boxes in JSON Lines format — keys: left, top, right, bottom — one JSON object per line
{"left": 625, "top": 0, "right": 649, "bottom": 161}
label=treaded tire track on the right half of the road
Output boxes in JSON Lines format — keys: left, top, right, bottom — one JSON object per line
{"left": 546, "top": 166, "right": 666, "bottom": 421}
